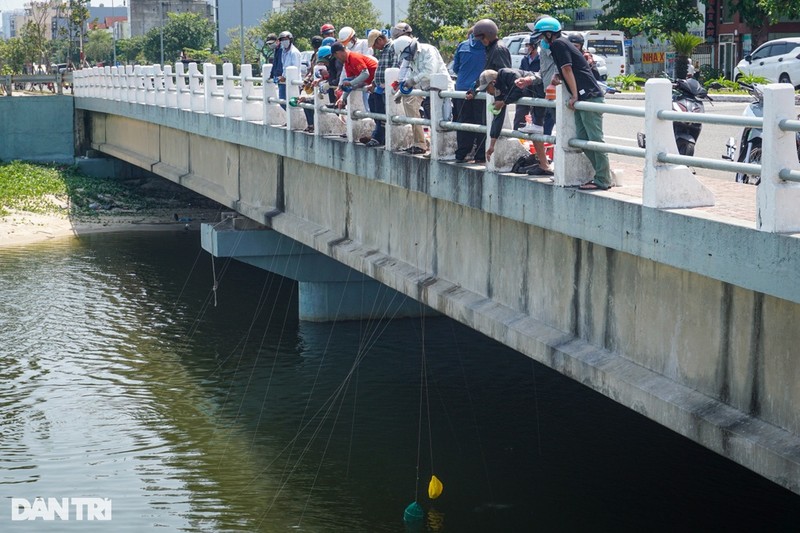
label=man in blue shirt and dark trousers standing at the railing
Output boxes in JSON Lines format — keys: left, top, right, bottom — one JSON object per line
{"left": 453, "top": 32, "right": 486, "bottom": 163}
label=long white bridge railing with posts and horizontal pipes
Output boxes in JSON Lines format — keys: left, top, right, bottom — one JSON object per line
{"left": 74, "top": 62, "right": 800, "bottom": 232}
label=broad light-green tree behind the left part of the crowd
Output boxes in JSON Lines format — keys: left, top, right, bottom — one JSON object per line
{"left": 254, "top": 0, "right": 380, "bottom": 48}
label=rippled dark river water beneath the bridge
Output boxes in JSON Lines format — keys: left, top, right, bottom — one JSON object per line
{"left": 0, "top": 232, "right": 800, "bottom": 532}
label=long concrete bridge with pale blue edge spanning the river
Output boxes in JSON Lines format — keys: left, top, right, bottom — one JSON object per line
{"left": 10, "top": 65, "right": 800, "bottom": 493}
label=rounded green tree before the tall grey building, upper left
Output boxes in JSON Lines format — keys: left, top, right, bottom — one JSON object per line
{"left": 144, "top": 13, "right": 215, "bottom": 63}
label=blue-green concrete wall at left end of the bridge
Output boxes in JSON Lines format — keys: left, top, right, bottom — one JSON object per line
{"left": 0, "top": 95, "right": 75, "bottom": 164}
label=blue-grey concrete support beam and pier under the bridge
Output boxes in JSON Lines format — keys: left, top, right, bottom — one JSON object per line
{"left": 201, "top": 217, "right": 437, "bottom": 322}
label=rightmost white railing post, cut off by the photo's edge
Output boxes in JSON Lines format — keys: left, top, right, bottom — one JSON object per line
{"left": 756, "top": 83, "right": 800, "bottom": 233}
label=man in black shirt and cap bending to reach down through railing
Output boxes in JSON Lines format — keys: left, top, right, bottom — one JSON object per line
{"left": 478, "top": 68, "right": 553, "bottom": 176}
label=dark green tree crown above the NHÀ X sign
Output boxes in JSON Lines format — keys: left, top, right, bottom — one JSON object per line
{"left": 597, "top": 0, "right": 703, "bottom": 41}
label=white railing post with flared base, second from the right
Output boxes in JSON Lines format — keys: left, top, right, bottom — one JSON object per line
{"left": 640, "top": 78, "right": 714, "bottom": 209}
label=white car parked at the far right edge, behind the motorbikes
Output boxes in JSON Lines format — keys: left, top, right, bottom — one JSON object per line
{"left": 733, "top": 37, "right": 800, "bottom": 87}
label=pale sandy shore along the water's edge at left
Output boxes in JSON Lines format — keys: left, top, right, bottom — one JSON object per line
{"left": 0, "top": 209, "right": 219, "bottom": 247}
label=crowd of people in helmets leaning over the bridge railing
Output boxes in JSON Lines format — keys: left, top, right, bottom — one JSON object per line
{"left": 267, "top": 15, "right": 612, "bottom": 190}
